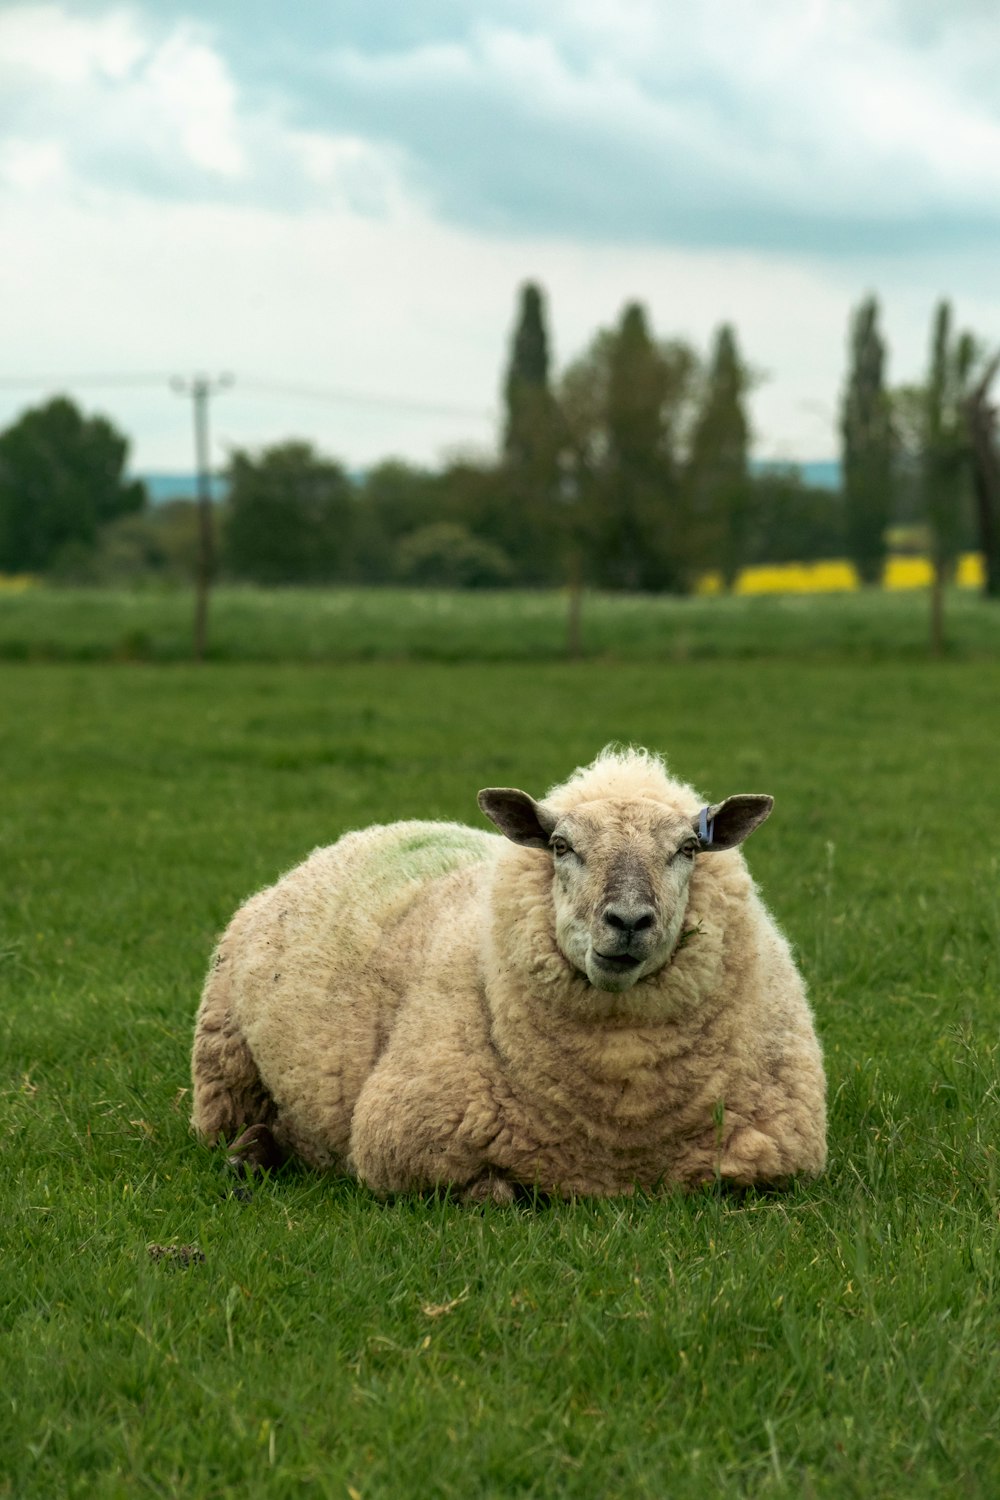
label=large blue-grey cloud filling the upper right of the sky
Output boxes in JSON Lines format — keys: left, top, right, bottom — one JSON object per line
{"left": 299, "top": 0, "right": 1000, "bottom": 254}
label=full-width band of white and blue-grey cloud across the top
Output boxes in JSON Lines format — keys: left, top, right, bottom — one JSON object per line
{"left": 0, "top": 0, "right": 1000, "bottom": 257}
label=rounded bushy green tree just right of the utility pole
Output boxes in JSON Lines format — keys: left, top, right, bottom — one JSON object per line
{"left": 225, "top": 441, "right": 354, "bottom": 584}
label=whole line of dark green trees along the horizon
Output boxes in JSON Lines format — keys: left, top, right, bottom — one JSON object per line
{"left": 0, "top": 284, "right": 1000, "bottom": 594}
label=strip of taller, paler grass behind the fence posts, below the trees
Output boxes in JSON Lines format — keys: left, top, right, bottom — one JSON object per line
{"left": 0, "top": 587, "right": 1000, "bottom": 663}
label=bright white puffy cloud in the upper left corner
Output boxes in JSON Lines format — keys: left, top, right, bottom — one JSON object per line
{"left": 0, "top": 3, "right": 413, "bottom": 213}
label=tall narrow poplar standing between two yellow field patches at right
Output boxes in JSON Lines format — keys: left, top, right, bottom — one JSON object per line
{"left": 841, "top": 297, "right": 892, "bottom": 584}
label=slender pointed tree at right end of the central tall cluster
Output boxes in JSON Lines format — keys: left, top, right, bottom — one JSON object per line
{"left": 688, "top": 323, "right": 753, "bottom": 588}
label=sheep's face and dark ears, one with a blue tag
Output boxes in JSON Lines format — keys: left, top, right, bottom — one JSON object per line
{"left": 478, "top": 788, "right": 774, "bottom": 992}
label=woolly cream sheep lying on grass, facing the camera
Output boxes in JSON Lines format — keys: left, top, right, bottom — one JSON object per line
{"left": 192, "top": 747, "right": 826, "bottom": 1203}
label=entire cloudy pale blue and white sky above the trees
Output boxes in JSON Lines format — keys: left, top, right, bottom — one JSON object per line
{"left": 0, "top": 0, "right": 1000, "bottom": 473}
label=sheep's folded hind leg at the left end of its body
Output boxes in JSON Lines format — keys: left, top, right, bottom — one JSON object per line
{"left": 192, "top": 954, "right": 274, "bottom": 1146}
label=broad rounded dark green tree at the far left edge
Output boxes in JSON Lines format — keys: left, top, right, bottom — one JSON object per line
{"left": 0, "top": 396, "right": 147, "bottom": 573}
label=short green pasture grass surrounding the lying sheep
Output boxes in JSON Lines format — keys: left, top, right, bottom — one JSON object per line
{"left": 0, "top": 660, "right": 1000, "bottom": 1500}
